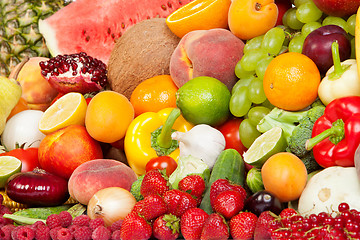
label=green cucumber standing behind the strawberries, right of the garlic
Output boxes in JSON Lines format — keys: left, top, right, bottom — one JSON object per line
{"left": 200, "top": 149, "right": 245, "bottom": 214}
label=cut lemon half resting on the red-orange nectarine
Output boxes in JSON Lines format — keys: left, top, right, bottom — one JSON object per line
{"left": 39, "top": 92, "right": 87, "bottom": 134}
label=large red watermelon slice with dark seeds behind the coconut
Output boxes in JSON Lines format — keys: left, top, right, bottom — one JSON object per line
{"left": 39, "top": 0, "right": 191, "bottom": 63}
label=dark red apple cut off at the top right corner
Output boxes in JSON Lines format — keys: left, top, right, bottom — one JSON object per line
{"left": 314, "top": 0, "right": 360, "bottom": 17}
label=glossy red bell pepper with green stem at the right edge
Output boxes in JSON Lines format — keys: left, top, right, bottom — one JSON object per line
{"left": 306, "top": 96, "right": 360, "bottom": 168}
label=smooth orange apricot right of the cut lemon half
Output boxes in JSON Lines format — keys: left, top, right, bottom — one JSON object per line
{"left": 86, "top": 90, "right": 134, "bottom": 143}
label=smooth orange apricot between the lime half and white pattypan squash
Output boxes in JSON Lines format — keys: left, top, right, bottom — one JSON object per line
{"left": 261, "top": 152, "right": 307, "bottom": 202}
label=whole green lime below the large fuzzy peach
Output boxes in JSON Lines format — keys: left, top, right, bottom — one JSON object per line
{"left": 176, "top": 76, "right": 231, "bottom": 126}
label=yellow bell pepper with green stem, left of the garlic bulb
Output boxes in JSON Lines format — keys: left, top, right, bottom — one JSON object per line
{"left": 124, "top": 108, "right": 193, "bottom": 175}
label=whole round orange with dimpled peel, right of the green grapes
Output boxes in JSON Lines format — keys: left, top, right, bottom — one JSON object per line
{"left": 263, "top": 52, "right": 321, "bottom": 111}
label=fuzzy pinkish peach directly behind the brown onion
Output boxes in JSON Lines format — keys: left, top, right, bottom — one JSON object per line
{"left": 68, "top": 159, "right": 137, "bottom": 205}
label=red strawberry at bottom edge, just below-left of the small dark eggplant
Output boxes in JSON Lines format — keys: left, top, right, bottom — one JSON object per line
{"left": 229, "top": 212, "right": 258, "bottom": 240}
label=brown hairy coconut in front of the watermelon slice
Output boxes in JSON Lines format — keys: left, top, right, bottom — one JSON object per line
{"left": 108, "top": 18, "right": 180, "bottom": 99}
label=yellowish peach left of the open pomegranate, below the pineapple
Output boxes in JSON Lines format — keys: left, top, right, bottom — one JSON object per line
{"left": 9, "top": 57, "right": 58, "bottom": 111}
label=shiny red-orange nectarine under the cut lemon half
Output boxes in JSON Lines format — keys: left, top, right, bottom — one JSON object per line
{"left": 39, "top": 125, "right": 103, "bottom": 179}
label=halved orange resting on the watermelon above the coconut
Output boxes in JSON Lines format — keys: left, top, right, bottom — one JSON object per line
{"left": 166, "top": 0, "right": 231, "bottom": 38}
